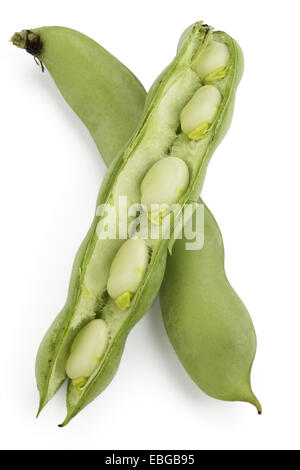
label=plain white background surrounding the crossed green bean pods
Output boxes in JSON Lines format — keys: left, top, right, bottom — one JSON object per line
{"left": 0, "top": 0, "right": 300, "bottom": 449}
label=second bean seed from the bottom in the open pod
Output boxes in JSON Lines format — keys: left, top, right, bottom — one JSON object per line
{"left": 107, "top": 239, "right": 149, "bottom": 310}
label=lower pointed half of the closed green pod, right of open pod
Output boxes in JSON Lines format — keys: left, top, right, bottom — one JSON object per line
{"left": 160, "top": 207, "right": 261, "bottom": 413}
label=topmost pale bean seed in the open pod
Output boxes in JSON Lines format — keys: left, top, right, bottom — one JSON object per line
{"left": 192, "top": 41, "right": 230, "bottom": 83}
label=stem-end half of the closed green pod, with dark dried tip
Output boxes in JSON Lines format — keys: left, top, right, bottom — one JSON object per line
{"left": 11, "top": 26, "right": 145, "bottom": 164}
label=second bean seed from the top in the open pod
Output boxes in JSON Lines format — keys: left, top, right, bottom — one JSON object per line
{"left": 180, "top": 85, "right": 222, "bottom": 140}
